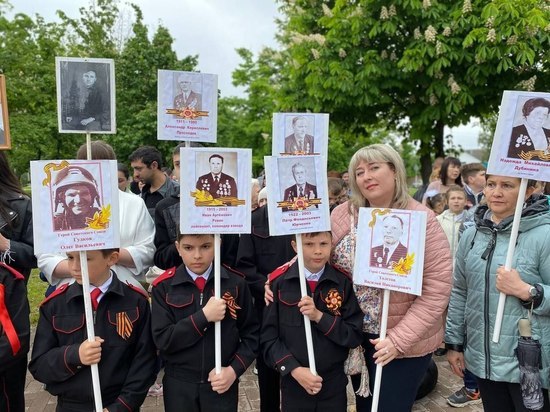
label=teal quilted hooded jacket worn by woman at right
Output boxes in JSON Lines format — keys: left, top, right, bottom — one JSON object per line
{"left": 445, "top": 195, "right": 550, "bottom": 388}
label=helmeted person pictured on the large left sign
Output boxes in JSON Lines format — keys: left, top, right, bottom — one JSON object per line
{"left": 53, "top": 166, "right": 101, "bottom": 230}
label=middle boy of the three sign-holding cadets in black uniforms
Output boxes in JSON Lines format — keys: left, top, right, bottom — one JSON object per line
{"left": 152, "top": 234, "right": 259, "bottom": 412}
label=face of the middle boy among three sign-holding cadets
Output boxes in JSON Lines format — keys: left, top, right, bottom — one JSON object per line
{"left": 176, "top": 235, "right": 214, "bottom": 275}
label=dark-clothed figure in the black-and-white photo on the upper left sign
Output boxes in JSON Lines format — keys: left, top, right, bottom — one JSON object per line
{"left": 63, "top": 66, "right": 110, "bottom": 131}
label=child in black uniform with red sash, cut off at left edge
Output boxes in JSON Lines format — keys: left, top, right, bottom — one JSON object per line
{"left": 0, "top": 262, "right": 30, "bottom": 412}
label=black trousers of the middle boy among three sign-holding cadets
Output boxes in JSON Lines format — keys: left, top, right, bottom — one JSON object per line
{"left": 162, "top": 373, "right": 239, "bottom": 412}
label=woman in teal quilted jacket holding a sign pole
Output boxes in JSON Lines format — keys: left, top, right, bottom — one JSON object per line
{"left": 445, "top": 175, "right": 550, "bottom": 412}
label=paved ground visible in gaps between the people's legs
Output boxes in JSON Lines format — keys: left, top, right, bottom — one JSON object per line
{"left": 25, "top": 357, "right": 483, "bottom": 412}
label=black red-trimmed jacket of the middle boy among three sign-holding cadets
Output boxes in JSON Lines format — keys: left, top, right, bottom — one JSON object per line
{"left": 152, "top": 265, "right": 259, "bottom": 383}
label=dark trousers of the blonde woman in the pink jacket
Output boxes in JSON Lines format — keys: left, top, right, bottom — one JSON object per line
{"left": 351, "top": 333, "right": 432, "bottom": 412}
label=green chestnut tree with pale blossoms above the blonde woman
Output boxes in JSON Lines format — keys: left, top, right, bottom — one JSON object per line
{"left": 280, "top": 0, "right": 550, "bottom": 177}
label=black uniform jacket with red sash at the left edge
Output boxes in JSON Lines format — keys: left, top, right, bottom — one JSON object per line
{"left": 0, "top": 262, "right": 30, "bottom": 374}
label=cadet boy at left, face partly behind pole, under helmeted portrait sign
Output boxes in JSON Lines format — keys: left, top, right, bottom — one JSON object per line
{"left": 29, "top": 249, "right": 155, "bottom": 412}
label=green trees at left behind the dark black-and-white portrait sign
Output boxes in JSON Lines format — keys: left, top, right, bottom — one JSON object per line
{"left": 0, "top": 0, "right": 197, "bottom": 174}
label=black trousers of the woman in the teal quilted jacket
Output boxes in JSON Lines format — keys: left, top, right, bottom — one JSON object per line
{"left": 477, "top": 378, "right": 550, "bottom": 412}
